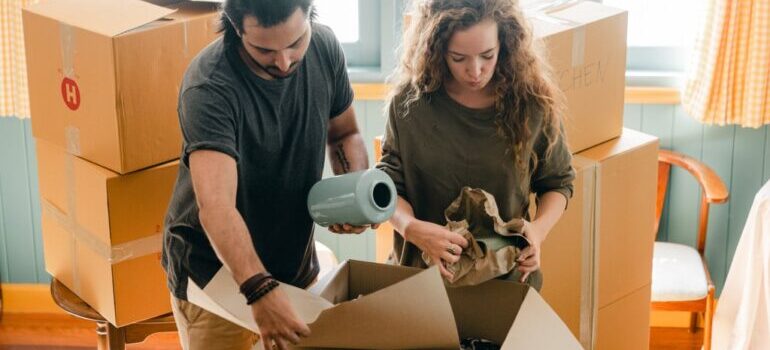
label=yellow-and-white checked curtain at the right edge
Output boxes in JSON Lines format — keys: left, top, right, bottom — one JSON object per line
{"left": 682, "top": 0, "right": 770, "bottom": 128}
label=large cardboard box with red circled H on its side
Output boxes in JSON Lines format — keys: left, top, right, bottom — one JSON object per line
{"left": 22, "top": 0, "right": 218, "bottom": 174}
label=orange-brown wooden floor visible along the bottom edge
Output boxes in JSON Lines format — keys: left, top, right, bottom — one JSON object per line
{"left": 0, "top": 314, "right": 703, "bottom": 350}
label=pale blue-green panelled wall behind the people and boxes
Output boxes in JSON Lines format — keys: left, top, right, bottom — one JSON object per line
{"left": 0, "top": 101, "right": 770, "bottom": 291}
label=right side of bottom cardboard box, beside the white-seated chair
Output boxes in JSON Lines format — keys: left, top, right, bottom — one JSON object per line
{"left": 595, "top": 285, "right": 651, "bottom": 350}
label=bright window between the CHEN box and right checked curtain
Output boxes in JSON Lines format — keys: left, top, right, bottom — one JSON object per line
{"left": 602, "top": 0, "right": 705, "bottom": 86}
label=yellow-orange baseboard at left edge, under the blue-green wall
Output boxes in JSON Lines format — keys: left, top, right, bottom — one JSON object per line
{"left": 2, "top": 283, "right": 65, "bottom": 314}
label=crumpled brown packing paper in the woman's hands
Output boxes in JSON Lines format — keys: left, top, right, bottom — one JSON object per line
{"left": 422, "top": 187, "right": 530, "bottom": 287}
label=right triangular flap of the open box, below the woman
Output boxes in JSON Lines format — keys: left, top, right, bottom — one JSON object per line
{"left": 501, "top": 290, "right": 583, "bottom": 350}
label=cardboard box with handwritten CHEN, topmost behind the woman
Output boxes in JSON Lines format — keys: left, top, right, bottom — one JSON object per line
{"left": 522, "top": 0, "right": 628, "bottom": 153}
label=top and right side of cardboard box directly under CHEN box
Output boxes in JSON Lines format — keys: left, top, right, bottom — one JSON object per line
{"left": 578, "top": 129, "right": 658, "bottom": 309}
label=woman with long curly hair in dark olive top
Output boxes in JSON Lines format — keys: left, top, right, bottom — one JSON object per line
{"left": 377, "top": 0, "right": 574, "bottom": 289}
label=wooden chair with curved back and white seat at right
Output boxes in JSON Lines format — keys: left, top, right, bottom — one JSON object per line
{"left": 651, "top": 150, "right": 729, "bottom": 350}
